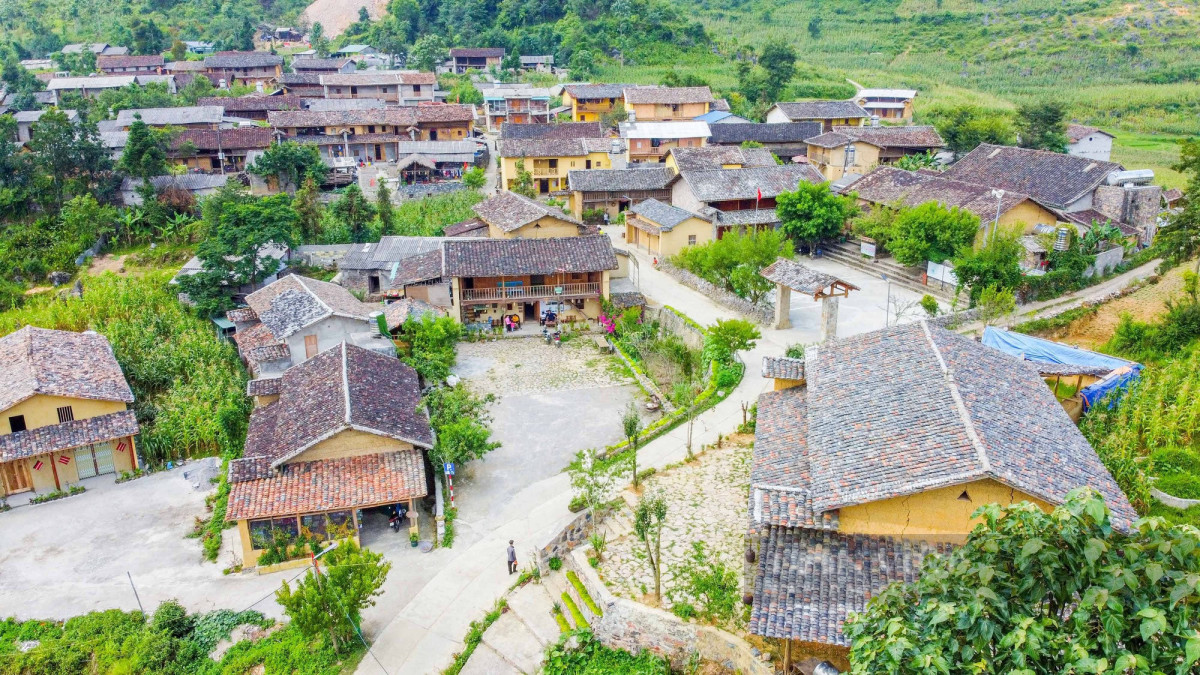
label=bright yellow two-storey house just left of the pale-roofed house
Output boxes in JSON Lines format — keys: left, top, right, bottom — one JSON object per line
{"left": 500, "top": 138, "right": 612, "bottom": 195}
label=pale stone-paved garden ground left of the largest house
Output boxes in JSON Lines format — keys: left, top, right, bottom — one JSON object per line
{"left": 599, "top": 442, "right": 751, "bottom": 609}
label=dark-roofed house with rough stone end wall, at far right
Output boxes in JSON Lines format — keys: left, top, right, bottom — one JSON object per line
{"left": 942, "top": 143, "right": 1163, "bottom": 246}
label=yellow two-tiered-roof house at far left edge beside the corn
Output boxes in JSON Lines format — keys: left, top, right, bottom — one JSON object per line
{"left": 0, "top": 325, "right": 138, "bottom": 503}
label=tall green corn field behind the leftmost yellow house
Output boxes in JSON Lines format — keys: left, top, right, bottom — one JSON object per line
{"left": 0, "top": 273, "right": 250, "bottom": 465}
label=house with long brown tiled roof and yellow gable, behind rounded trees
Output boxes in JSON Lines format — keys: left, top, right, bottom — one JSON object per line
{"left": 850, "top": 167, "right": 1058, "bottom": 246}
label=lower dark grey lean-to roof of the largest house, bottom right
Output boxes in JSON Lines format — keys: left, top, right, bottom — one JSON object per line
{"left": 749, "top": 526, "right": 953, "bottom": 645}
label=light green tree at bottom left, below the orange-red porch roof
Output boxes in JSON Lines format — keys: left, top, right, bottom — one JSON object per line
{"left": 275, "top": 539, "right": 391, "bottom": 653}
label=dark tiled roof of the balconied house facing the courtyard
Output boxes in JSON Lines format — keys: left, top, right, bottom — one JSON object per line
{"left": 443, "top": 234, "right": 617, "bottom": 277}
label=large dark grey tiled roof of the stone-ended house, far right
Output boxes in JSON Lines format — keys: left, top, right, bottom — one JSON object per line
{"left": 944, "top": 143, "right": 1123, "bottom": 209}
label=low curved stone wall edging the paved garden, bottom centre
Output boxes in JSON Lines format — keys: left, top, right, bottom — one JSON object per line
{"left": 565, "top": 549, "right": 775, "bottom": 675}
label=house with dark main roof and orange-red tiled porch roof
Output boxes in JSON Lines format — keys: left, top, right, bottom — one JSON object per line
{"left": 226, "top": 342, "right": 433, "bottom": 567}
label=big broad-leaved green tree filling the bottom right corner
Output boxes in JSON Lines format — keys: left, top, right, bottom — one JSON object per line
{"left": 845, "top": 488, "right": 1200, "bottom": 675}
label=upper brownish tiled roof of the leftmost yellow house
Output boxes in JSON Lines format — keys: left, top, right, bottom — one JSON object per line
{"left": 0, "top": 325, "right": 133, "bottom": 411}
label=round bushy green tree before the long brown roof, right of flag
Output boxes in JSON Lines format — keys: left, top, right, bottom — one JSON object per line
{"left": 888, "top": 202, "right": 979, "bottom": 265}
